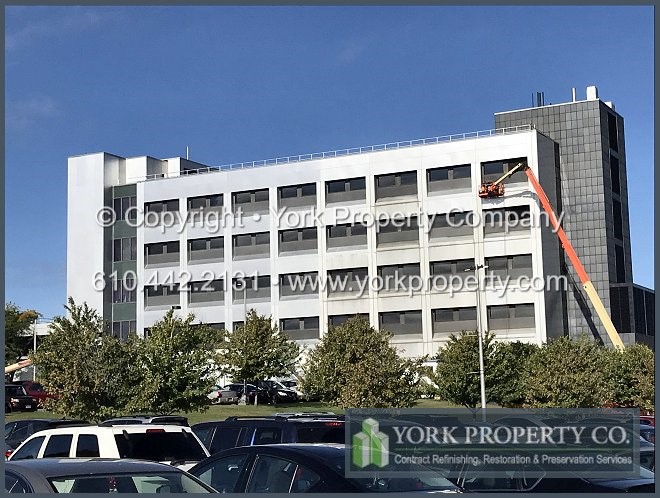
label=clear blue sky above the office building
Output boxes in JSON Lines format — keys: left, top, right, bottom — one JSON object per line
{"left": 5, "top": 6, "right": 654, "bottom": 317}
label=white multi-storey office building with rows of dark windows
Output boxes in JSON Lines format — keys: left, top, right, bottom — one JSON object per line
{"left": 67, "top": 86, "right": 652, "bottom": 356}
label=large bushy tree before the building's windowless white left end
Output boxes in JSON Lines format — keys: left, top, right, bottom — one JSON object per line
{"left": 32, "top": 298, "right": 135, "bottom": 421}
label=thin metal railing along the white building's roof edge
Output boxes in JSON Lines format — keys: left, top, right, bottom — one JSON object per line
{"left": 134, "top": 124, "right": 534, "bottom": 182}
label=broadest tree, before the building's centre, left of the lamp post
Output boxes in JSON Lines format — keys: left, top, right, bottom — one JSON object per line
{"left": 303, "top": 316, "right": 424, "bottom": 408}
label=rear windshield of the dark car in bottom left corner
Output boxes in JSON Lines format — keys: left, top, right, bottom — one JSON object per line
{"left": 48, "top": 471, "right": 213, "bottom": 493}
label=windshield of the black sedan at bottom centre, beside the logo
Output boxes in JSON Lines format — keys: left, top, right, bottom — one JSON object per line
{"left": 330, "top": 457, "right": 458, "bottom": 493}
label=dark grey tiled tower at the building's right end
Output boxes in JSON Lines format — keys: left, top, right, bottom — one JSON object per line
{"left": 495, "top": 87, "right": 640, "bottom": 344}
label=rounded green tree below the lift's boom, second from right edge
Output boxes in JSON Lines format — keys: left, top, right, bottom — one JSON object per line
{"left": 525, "top": 337, "right": 611, "bottom": 408}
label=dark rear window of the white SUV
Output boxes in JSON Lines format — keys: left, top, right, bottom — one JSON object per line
{"left": 115, "top": 431, "right": 206, "bottom": 462}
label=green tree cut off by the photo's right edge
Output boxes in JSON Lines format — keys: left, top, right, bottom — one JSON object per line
{"left": 604, "top": 344, "right": 655, "bottom": 412}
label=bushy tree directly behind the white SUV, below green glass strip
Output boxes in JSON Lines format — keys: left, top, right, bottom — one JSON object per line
{"left": 126, "top": 310, "right": 225, "bottom": 414}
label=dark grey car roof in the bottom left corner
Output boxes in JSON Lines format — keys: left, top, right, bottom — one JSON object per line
{"left": 5, "top": 458, "right": 178, "bottom": 477}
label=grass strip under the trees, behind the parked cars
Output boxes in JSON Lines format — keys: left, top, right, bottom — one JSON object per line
{"left": 5, "top": 399, "right": 455, "bottom": 425}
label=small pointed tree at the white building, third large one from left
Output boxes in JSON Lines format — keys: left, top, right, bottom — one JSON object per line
{"left": 220, "top": 310, "right": 300, "bottom": 382}
